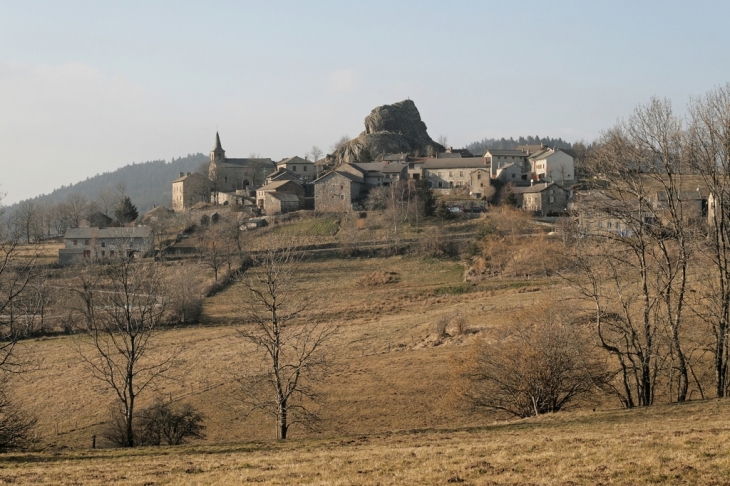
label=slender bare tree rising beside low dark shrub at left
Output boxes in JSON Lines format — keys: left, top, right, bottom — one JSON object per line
{"left": 76, "top": 258, "right": 179, "bottom": 447}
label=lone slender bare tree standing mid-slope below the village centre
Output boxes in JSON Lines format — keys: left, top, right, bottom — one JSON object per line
{"left": 238, "top": 240, "right": 337, "bottom": 439}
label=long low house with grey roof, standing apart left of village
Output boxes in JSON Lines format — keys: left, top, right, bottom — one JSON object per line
{"left": 58, "top": 226, "right": 154, "bottom": 265}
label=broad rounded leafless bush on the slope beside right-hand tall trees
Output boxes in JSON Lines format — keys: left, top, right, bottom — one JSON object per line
{"left": 454, "top": 306, "right": 607, "bottom": 418}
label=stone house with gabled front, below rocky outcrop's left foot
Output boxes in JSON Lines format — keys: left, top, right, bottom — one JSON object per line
{"left": 314, "top": 171, "right": 367, "bottom": 213}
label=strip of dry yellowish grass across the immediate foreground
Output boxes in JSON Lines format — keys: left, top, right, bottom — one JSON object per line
{"left": 0, "top": 400, "right": 730, "bottom": 486}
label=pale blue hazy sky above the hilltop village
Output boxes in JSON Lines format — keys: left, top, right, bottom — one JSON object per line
{"left": 0, "top": 0, "right": 730, "bottom": 204}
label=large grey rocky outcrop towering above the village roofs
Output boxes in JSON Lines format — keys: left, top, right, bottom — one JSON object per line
{"left": 325, "top": 100, "right": 446, "bottom": 167}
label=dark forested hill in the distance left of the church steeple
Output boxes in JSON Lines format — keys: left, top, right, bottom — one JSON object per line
{"left": 7, "top": 153, "right": 208, "bottom": 214}
